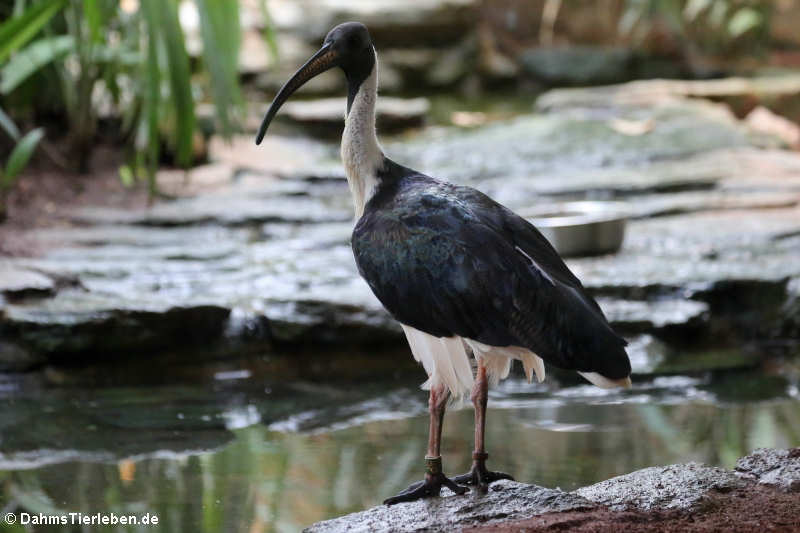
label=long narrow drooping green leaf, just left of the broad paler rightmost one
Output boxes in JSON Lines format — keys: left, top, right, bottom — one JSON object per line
{"left": 159, "top": 0, "right": 195, "bottom": 167}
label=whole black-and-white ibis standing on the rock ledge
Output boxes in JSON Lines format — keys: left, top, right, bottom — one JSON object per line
{"left": 256, "top": 22, "right": 631, "bottom": 505}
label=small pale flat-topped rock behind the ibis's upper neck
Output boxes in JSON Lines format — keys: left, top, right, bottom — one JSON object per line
{"left": 281, "top": 97, "right": 430, "bottom": 138}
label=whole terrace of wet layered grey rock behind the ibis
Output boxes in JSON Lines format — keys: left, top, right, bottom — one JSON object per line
{"left": 0, "top": 89, "right": 800, "bottom": 373}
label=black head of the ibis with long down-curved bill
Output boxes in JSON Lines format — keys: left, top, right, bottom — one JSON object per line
{"left": 256, "top": 22, "right": 375, "bottom": 144}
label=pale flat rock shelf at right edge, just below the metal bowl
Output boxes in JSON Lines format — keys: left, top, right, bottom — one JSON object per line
{"left": 569, "top": 208, "right": 800, "bottom": 300}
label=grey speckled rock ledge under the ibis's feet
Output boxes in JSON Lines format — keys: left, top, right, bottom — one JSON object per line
{"left": 305, "top": 448, "right": 800, "bottom": 533}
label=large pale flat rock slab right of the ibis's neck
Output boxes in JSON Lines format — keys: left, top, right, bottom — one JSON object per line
{"left": 387, "top": 93, "right": 751, "bottom": 191}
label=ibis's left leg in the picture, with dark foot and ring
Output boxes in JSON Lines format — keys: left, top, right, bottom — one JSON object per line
{"left": 383, "top": 385, "right": 469, "bottom": 505}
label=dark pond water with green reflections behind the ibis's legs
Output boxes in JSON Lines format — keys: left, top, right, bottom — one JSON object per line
{"left": 0, "top": 360, "right": 800, "bottom": 532}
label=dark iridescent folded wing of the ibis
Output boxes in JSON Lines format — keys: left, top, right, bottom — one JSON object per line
{"left": 353, "top": 182, "right": 630, "bottom": 379}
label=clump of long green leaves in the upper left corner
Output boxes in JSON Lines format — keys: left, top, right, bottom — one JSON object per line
{"left": 0, "top": 0, "right": 256, "bottom": 216}
